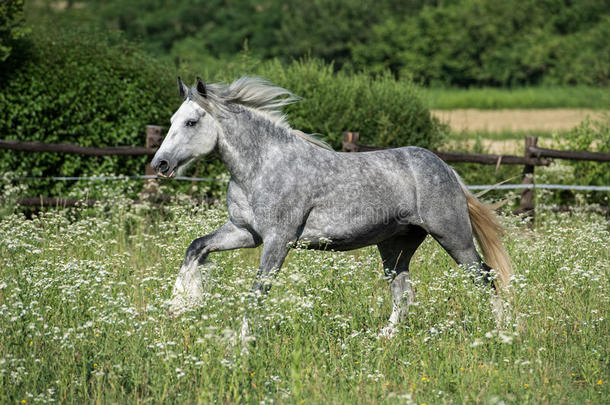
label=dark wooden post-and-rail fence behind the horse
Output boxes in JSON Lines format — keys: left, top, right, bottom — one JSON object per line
{"left": 0, "top": 125, "right": 610, "bottom": 216}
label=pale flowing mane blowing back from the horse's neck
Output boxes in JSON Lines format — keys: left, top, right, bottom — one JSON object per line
{"left": 188, "top": 76, "right": 333, "bottom": 150}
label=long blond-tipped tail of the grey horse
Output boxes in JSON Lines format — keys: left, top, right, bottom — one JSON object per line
{"left": 454, "top": 172, "right": 513, "bottom": 290}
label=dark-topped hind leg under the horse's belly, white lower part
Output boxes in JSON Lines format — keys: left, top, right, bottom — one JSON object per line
{"left": 377, "top": 227, "right": 427, "bottom": 336}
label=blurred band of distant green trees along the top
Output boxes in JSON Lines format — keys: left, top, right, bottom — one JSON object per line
{"left": 61, "top": 0, "right": 610, "bottom": 87}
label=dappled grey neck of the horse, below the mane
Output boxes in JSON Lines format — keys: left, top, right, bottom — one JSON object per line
{"left": 218, "top": 109, "right": 285, "bottom": 183}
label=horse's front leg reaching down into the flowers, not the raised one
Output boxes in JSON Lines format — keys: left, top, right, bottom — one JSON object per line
{"left": 240, "top": 235, "right": 289, "bottom": 344}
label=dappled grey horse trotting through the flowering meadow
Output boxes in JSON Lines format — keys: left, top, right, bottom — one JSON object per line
{"left": 152, "top": 77, "right": 512, "bottom": 333}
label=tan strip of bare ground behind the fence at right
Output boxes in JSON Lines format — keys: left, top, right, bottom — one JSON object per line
{"left": 432, "top": 109, "right": 610, "bottom": 132}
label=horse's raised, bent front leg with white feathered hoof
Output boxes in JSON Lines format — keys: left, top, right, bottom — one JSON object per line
{"left": 170, "top": 220, "right": 260, "bottom": 313}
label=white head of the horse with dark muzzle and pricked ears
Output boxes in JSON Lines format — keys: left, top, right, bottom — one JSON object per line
{"left": 151, "top": 78, "right": 220, "bottom": 177}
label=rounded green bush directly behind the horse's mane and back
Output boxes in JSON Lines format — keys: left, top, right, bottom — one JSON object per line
{"left": 202, "top": 58, "right": 446, "bottom": 149}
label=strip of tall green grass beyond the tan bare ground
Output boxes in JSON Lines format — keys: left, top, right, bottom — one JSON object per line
{"left": 423, "top": 86, "right": 610, "bottom": 110}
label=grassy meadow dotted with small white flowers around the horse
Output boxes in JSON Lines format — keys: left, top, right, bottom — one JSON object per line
{"left": 0, "top": 192, "right": 610, "bottom": 404}
